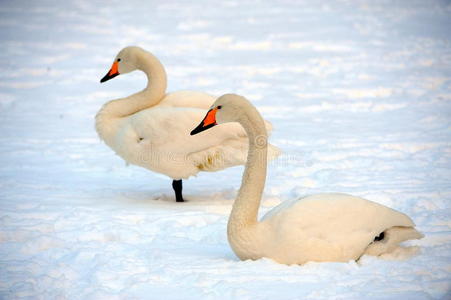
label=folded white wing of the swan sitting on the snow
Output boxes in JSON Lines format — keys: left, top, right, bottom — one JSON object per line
{"left": 262, "top": 194, "right": 418, "bottom": 261}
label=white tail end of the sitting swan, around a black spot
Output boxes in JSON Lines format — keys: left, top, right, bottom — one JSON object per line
{"left": 364, "top": 226, "right": 424, "bottom": 256}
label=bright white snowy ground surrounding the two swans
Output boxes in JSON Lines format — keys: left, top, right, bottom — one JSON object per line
{"left": 0, "top": 0, "right": 451, "bottom": 299}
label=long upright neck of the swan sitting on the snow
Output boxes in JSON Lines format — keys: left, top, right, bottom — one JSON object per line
{"left": 228, "top": 106, "right": 267, "bottom": 236}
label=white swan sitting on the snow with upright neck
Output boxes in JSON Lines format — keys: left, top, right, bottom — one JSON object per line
{"left": 191, "top": 94, "right": 423, "bottom": 264}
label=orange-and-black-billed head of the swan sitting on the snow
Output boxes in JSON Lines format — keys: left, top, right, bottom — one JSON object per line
{"left": 191, "top": 94, "right": 251, "bottom": 135}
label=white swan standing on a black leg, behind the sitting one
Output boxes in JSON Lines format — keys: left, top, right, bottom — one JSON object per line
{"left": 96, "top": 47, "right": 278, "bottom": 202}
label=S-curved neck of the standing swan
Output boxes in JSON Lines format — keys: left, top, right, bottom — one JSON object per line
{"left": 96, "top": 50, "right": 167, "bottom": 144}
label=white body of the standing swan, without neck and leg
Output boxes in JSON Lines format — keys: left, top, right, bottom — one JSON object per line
{"left": 110, "top": 106, "right": 279, "bottom": 179}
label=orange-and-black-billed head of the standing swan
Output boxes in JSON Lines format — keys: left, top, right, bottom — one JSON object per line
{"left": 100, "top": 46, "right": 144, "bottom": 82}
